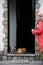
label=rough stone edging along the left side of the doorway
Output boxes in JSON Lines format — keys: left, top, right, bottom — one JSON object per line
{"left": 2, "top": 0, "right": 8, "bottom": 60}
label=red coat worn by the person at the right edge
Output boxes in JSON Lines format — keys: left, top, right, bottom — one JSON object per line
{"left": 32, "top": 20, "right": 43, "bottom": 52}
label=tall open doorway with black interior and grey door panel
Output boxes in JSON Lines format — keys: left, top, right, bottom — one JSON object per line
{"left": 8, "top": 0, "right": 35, "bottom": 53}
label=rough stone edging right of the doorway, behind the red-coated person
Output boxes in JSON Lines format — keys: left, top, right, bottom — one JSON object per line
{"left": 35, "top": 0, "right": 41, "bottom": 51}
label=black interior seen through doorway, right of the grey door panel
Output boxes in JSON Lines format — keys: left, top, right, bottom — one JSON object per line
{"left": 8, "top": 0, "right": 35, "bottom": 53}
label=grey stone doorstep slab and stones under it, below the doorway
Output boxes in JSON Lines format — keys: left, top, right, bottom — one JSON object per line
{"left": 7, "top": 54, "right": 35, "bottom": 60}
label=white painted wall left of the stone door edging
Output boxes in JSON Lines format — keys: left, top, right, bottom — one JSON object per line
{"left": 0, "top": 0, "right": 4, "bottom": 51}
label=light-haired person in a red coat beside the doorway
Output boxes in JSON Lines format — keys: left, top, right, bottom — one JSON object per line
{"left": 32, "top": 14, "right": 43, "bottom": 58}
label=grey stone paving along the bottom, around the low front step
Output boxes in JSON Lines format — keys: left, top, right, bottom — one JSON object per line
{"left": 0, "top": 61, "right": 43, "bottom": 65}
